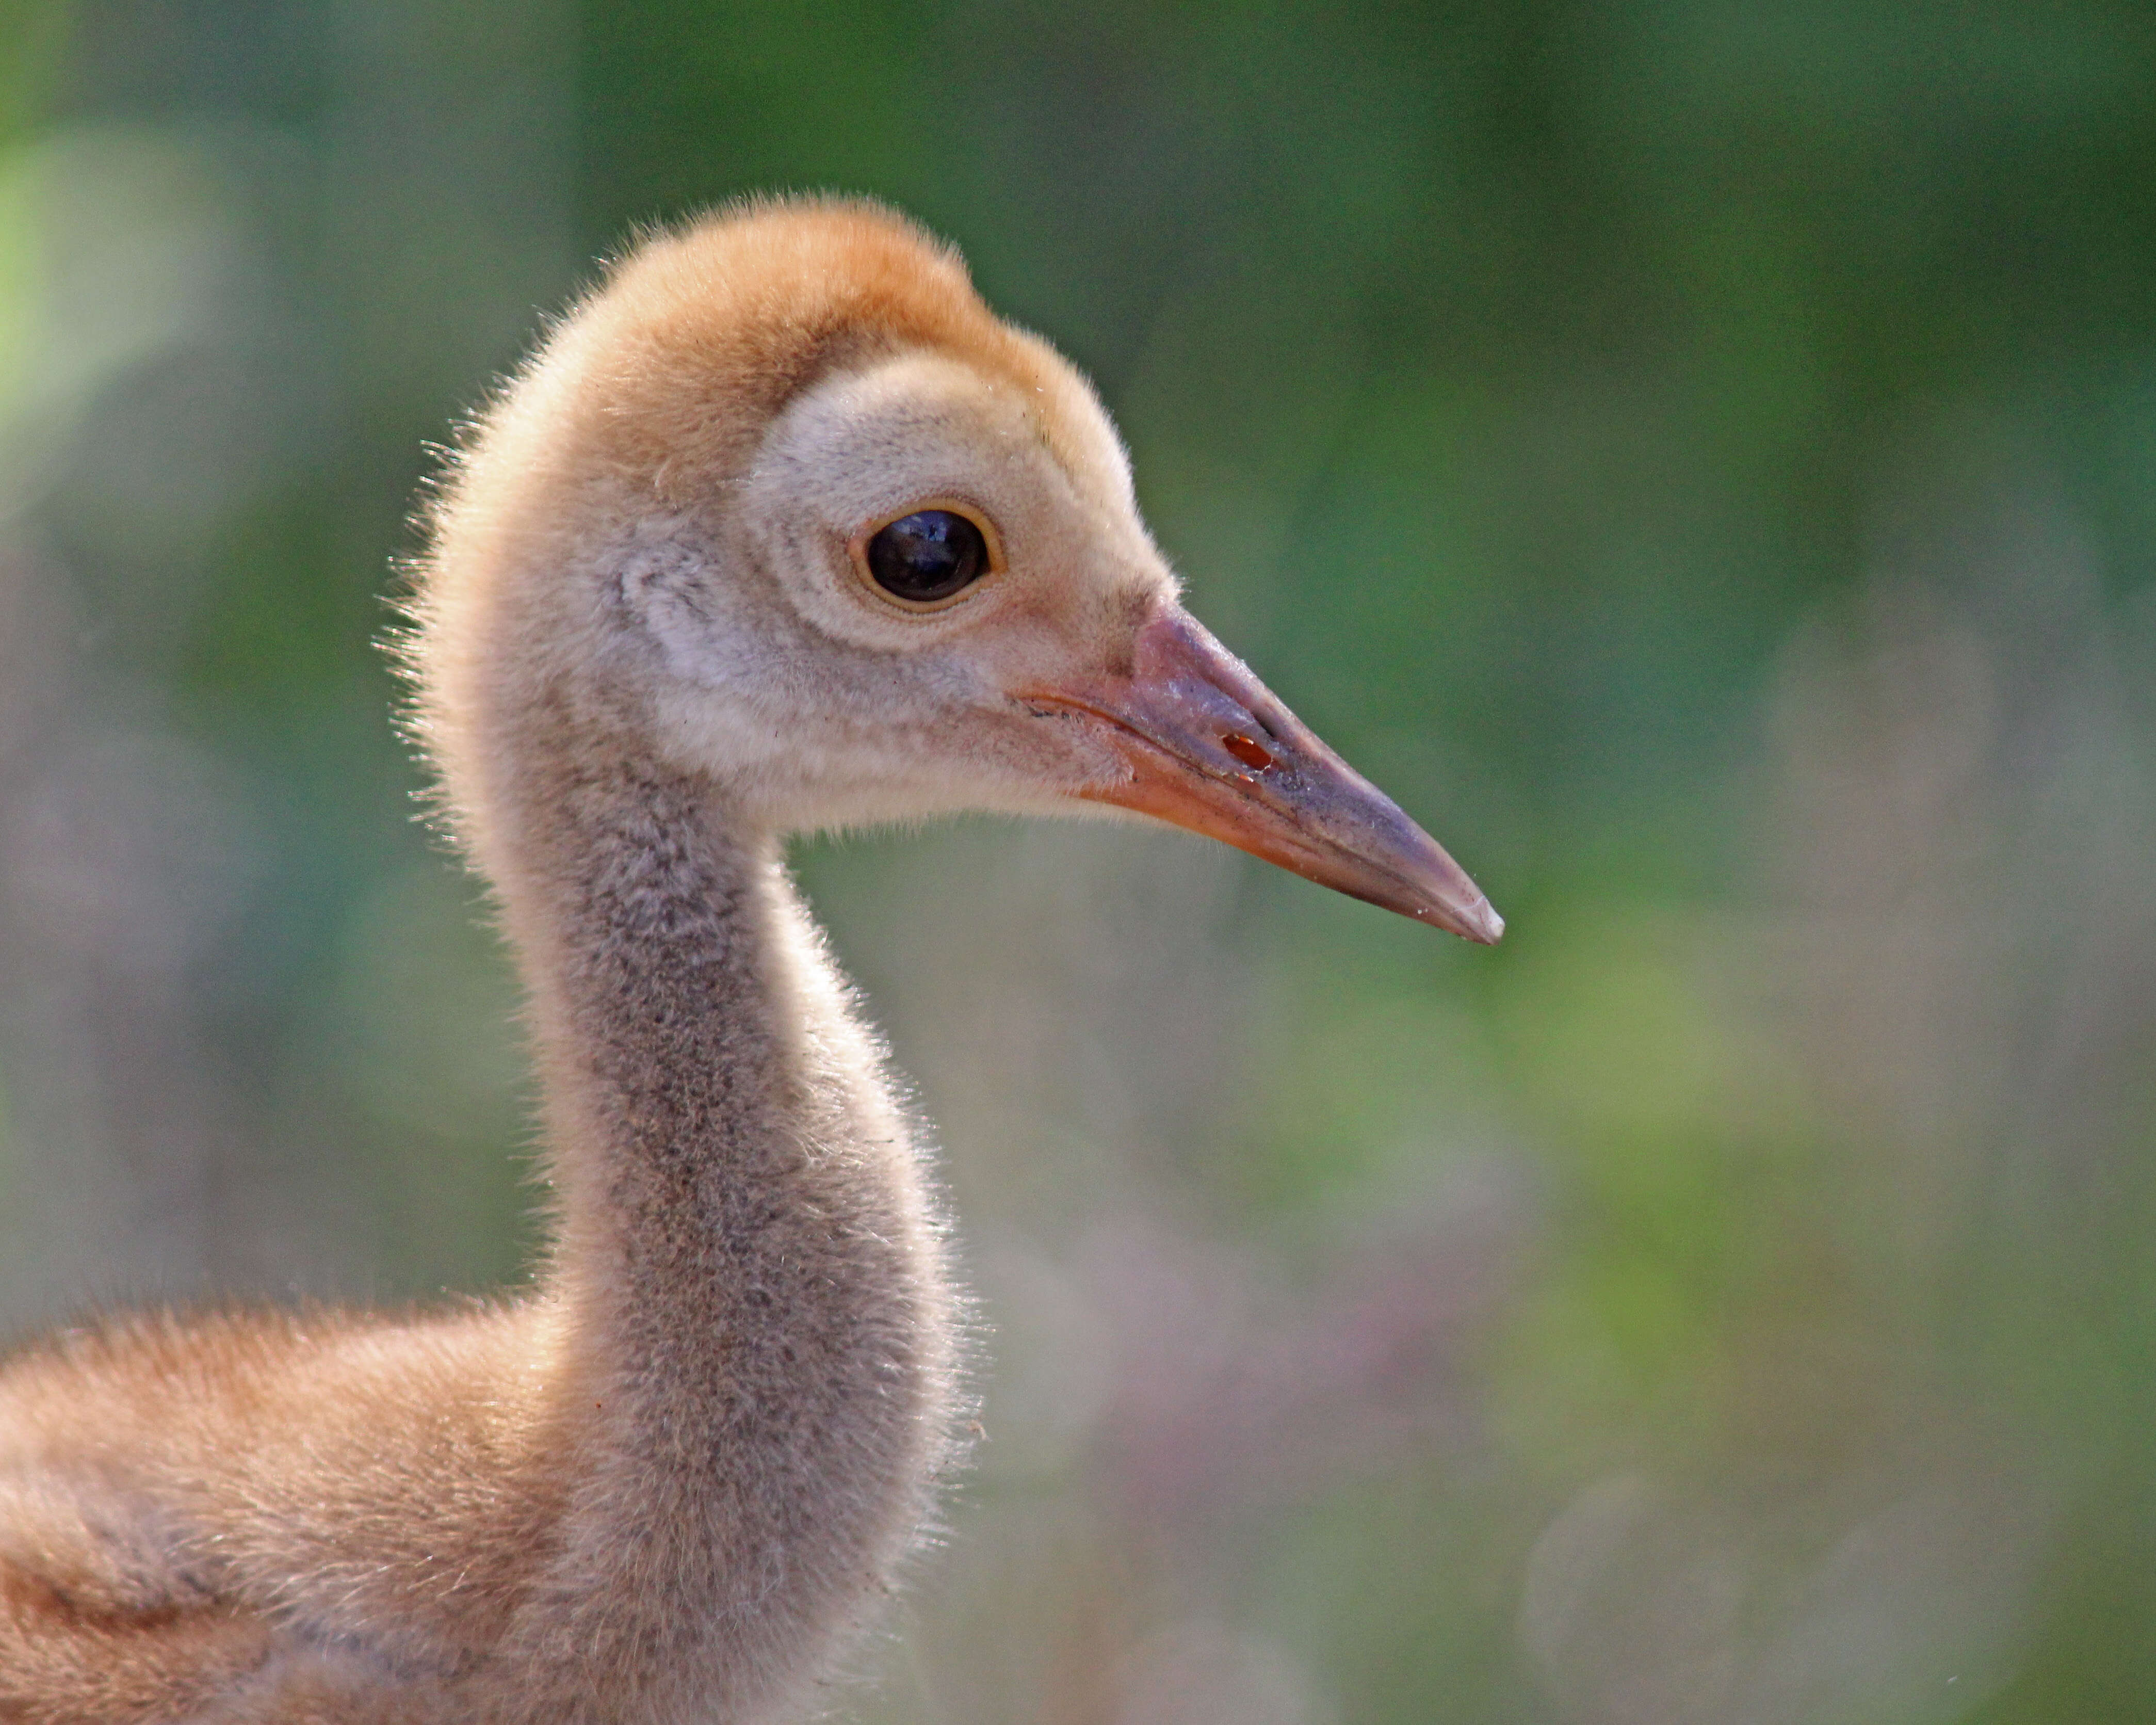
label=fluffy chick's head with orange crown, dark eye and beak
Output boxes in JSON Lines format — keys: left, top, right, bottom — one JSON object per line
{"left": 420, "top": 203, "right": 1503, "bottom": 942}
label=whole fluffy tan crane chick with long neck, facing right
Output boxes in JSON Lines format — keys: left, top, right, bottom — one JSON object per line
{"left": 0, "top": 203, "right": 1498, "bottom": 1725}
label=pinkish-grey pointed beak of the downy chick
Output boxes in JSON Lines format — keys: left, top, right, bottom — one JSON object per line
{"left": 1013, "top": 606, "right": 1505, "bottom": 944}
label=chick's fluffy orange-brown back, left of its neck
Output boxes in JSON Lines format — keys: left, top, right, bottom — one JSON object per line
{"left": 0, "top": 1307, "right": 545, "bottom": 1725}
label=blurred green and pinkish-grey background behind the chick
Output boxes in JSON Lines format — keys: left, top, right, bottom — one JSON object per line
{"left": 0, "top": 0, "right": 2156, "bottom": 1725}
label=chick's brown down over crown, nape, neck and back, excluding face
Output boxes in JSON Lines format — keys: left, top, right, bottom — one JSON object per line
{"left": 0, "top": 207, "right": 983, "bottom": 1725}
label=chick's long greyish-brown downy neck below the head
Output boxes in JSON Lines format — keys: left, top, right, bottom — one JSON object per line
{"left": 500, "top": 724, "right": 953, "bottom": 1718}
